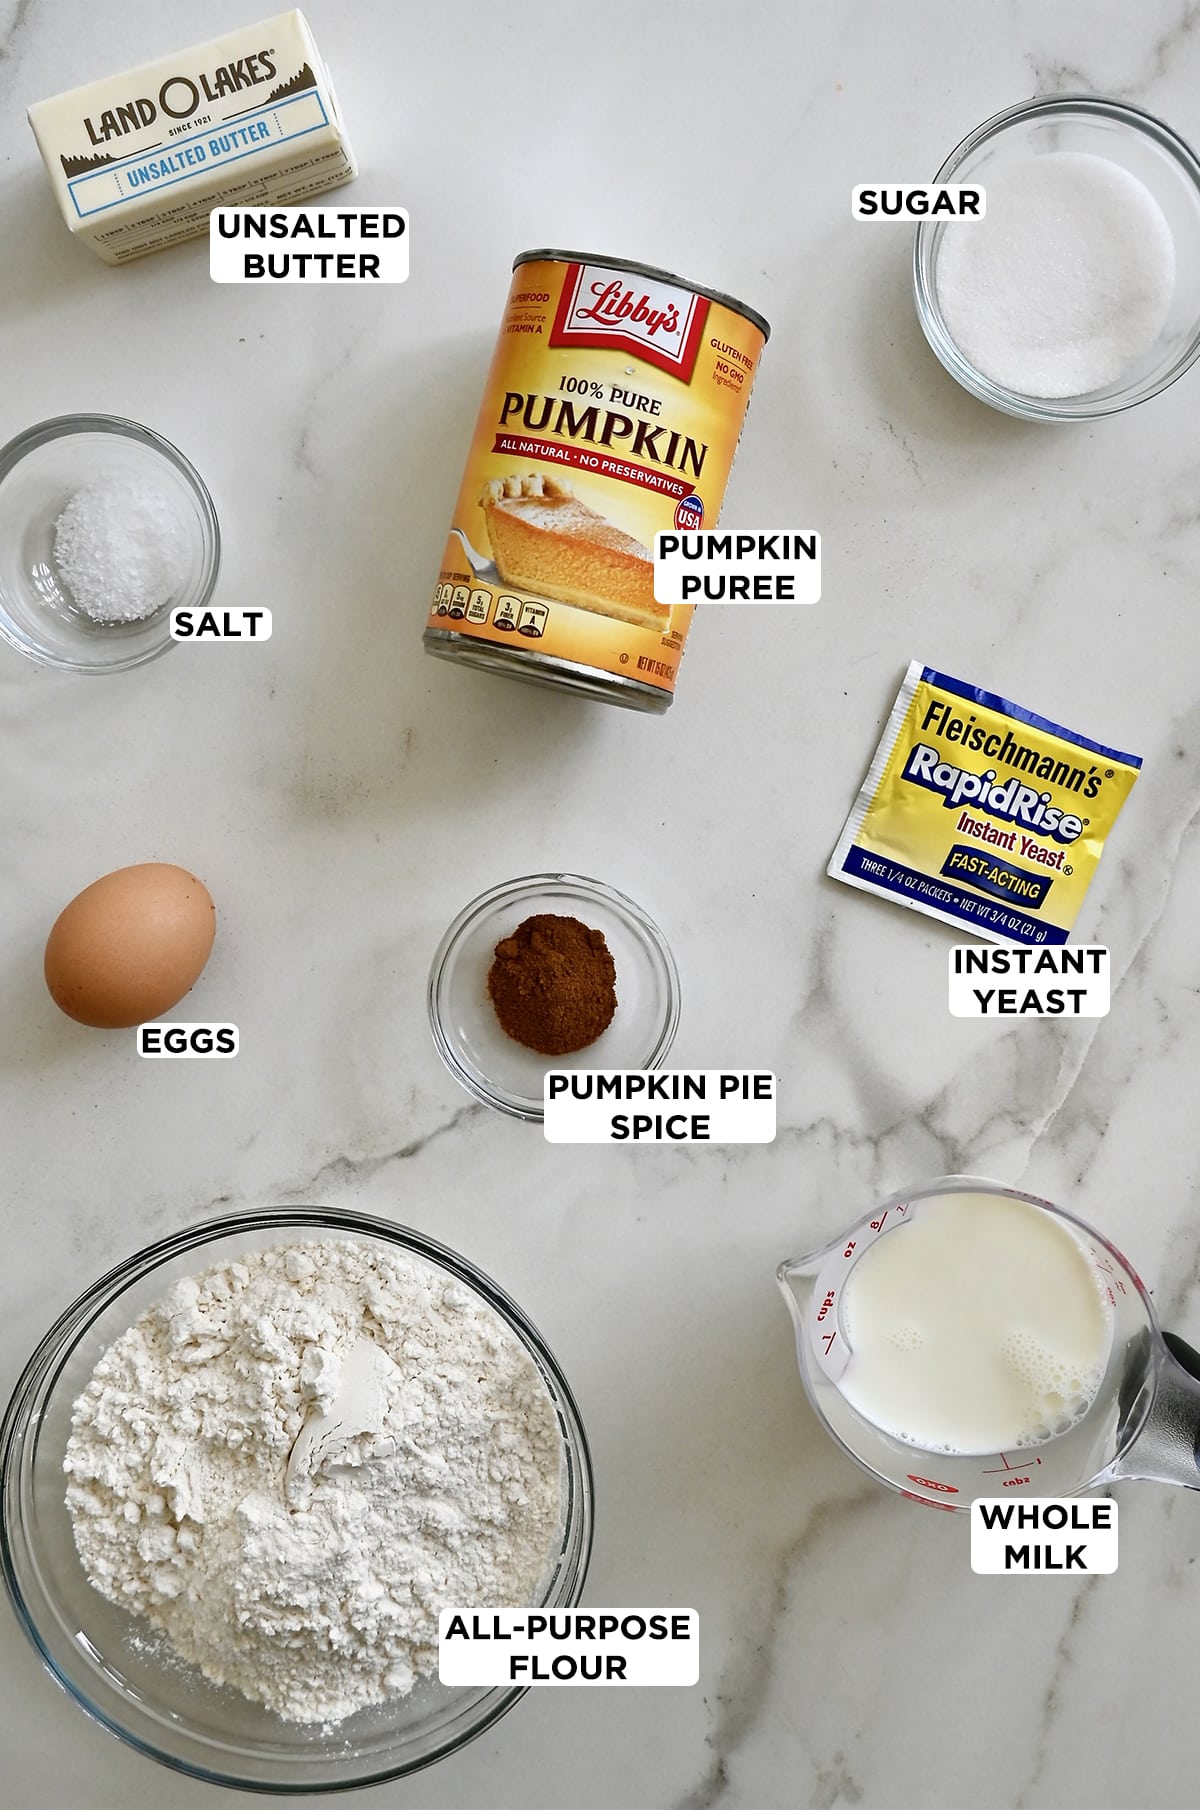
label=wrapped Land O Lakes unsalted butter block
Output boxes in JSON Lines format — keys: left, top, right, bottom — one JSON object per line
{"left": 29, "top": 13, "right": 357, "bottom": 264}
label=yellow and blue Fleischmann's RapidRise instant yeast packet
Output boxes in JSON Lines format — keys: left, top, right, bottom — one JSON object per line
{"left": 829, "top": 661, "right": 1142, "bottom": 943}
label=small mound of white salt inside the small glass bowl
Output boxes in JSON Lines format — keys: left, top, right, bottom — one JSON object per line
{"left": 54, "top": 478, "right": 190, "bottom": 623}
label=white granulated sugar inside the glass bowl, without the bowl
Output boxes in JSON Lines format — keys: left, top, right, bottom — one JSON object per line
{"left": 936, "top": 150, "right": 1175, "bottom": 398}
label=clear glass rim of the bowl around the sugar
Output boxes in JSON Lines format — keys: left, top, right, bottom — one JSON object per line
{"left": 912, "top": 94, "right": 1200, "bottom": 422}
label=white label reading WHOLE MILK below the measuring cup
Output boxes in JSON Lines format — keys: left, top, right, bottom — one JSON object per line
{"left": 970, "top": 1495, "right": 1117, "bottom": 1577}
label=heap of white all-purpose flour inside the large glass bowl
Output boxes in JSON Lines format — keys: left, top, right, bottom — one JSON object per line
{"left": 63, "top": 1240, "right": 561, "bottom": 1723}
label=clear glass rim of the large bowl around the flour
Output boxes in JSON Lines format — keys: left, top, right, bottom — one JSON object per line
{"left": 0, "top": 1205, "right": 595, "bottom": 1797}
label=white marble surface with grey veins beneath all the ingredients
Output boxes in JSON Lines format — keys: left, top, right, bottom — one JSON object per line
{"left": 0, "top": 0, "right": 1200, "bottom": 1810}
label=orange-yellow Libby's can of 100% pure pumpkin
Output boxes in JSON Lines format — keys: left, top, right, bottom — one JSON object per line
{"left": 425, "top": 252, "right": 771, "bottom": 711}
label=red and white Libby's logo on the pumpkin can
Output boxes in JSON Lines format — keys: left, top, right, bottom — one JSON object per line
{"left": 550, "top": 264, "right": 708, "bottom": 384}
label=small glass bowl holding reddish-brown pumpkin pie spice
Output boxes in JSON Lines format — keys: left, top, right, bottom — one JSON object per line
{"left": 429, "top": 874, "right": 679, "bottom": 1120}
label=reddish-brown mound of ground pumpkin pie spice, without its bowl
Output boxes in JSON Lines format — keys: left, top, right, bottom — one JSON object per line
{"left": 487, "top": 912, "right": 617, "bottom": 1055}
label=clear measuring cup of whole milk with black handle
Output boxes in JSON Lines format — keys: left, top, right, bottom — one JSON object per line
{"left": 776, "top": 1175, "right": 1200, "bottom": 1510}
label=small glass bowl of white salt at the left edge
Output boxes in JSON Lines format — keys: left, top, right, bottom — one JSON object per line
{"left": 0, "top": 414, "right": 221, "bottom": 673}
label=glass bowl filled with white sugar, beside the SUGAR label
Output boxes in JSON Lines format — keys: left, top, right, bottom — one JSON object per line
{"left": 912, "top": 94, "right": 1200, "bottom": 422}
